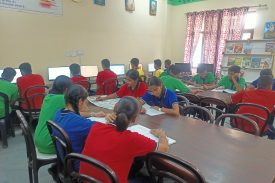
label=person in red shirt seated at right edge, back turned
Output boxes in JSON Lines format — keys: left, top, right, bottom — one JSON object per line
{"left": 231, "top": 75, "right": 275, "bottom": 133}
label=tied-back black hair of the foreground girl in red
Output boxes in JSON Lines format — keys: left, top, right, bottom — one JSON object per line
{"left": 114, "top": 97, "right": 140, "bottom": 132}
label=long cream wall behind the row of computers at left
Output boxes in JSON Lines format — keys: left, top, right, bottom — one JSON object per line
{"left": 0, "top": 0, "right": 169, "bottom": 83}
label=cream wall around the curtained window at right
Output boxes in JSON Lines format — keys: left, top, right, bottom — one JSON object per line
{"left": 168, "top": 0, "right": 275, "bottom": 61}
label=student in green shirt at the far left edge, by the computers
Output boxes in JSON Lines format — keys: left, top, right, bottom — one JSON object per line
{"left": 0, "top": 67, "right": 18, "bottom": 118}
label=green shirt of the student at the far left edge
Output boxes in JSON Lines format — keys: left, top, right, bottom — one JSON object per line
{"left": 0, "top": 79, "right": 18, "bottom": 118}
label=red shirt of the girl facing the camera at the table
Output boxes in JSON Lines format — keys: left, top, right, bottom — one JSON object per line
{"left": 116, "top": 82, "right": 146, "bottom": 98}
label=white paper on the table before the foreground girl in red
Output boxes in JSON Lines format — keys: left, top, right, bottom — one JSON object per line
{"left": 128, "top": 125, "right": 176, "bottom": 145}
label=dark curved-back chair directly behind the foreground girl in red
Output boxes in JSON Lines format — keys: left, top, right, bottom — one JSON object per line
{"left": 65, "top": 153, "right": 118, "bottom": 183}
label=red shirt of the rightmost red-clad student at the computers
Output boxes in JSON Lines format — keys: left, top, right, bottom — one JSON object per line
{"left": 96, "top": 69, "right": 117, "bottom": 95}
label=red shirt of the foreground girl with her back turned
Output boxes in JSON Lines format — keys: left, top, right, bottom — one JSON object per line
{"left": 80, "top": 123, "right": 157, "bottom": 183}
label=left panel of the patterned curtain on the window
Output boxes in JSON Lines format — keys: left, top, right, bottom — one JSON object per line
{"left": 184, "top": 12, "right": 204, "bottom": 63}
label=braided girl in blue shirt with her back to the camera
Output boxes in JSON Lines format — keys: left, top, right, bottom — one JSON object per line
{"left": 53, "top": 85, "right": 105, "bottom": 169}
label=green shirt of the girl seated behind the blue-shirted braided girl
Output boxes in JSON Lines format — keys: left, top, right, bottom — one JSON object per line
{"left": 34, "top": 94, "right": 65, "bottom": 154}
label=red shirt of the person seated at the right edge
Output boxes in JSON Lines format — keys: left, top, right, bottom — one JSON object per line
{"left": 231, "top": 89, "right": 275, "bottom": 133}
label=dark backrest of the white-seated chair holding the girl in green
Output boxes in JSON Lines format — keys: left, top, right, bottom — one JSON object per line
{"left": 16, "top": 110, "right": 37, "bottom": 161}
